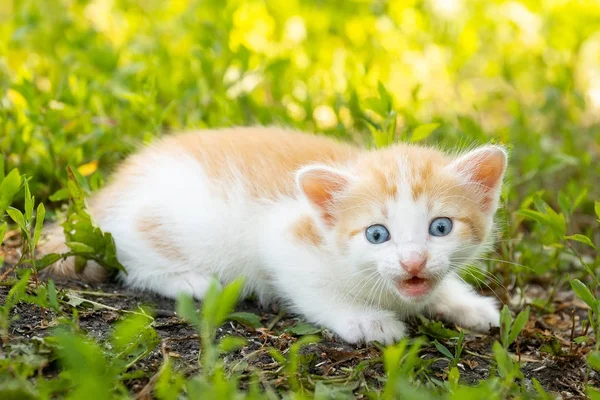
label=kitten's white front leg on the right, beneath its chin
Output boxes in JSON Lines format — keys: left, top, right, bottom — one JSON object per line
{"left": 430, "top": 275, "right": 500, "bottom": 332}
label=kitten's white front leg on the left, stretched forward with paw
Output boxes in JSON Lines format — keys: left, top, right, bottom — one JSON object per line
{"left": 292, "top": 292, "right": 407, "bottom": 344}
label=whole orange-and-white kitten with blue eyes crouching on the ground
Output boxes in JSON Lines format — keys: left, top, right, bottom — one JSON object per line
{"left": 42, "top": 128, "right": 507, "bottom": 343}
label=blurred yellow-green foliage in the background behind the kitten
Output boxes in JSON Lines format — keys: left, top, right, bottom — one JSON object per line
{"left": 0, "top": 0, "right": 600, "bottom": 296}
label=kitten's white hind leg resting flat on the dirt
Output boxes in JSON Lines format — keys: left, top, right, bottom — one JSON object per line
{"left": 125, "top": 272, "right": 210, "bottom": 300}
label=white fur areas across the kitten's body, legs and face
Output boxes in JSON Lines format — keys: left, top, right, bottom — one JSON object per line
{"left": 89, "top": 149, "right": 499, "bottom": 343}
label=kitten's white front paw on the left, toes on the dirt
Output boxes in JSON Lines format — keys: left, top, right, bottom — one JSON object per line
{"left": 334, "top": 311, "right": 407, "bottom": 344}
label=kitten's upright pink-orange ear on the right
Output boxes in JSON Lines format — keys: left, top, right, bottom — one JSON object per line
{"left": 450, "top": 145, "right": 508, "bottom": 213}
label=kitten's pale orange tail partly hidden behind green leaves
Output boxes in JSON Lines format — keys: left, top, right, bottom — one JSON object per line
{"left": 37, "top": 223, "right": 108, "bottom": 283}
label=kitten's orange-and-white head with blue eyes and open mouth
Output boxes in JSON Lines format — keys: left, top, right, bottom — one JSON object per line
{"left": 297, "top": 145, "right": 507, "bottom": 302}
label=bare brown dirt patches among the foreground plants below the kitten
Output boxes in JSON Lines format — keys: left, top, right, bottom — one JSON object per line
{"left": 0, "top": 276, "right": 597, "bottom": 398}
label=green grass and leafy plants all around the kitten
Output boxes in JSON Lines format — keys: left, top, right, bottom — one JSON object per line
{"left": 0, "top": 0, "right": 600, "bottom": 399}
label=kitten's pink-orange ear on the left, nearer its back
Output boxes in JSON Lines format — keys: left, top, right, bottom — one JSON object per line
{"left": 296, "top": 165, "right": 351, "bottom": 226}
